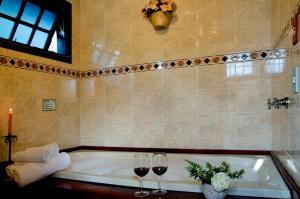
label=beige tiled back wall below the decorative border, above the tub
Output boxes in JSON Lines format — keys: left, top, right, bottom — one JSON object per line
{"left": 80, "top": 60, "right": 272, "bottom": 150}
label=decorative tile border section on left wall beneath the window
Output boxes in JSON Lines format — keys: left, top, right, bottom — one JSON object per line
{"left": 0, "top": 55, "right": 80, "bottom": 78}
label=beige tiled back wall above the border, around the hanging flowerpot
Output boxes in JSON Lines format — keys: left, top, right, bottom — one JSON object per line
{"left": 80, "top": 0, "right": 271, "bottom": 70}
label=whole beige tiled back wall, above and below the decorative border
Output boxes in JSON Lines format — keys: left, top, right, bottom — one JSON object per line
{"left": 80, "top": 0, "right": 272, "bottom": 150}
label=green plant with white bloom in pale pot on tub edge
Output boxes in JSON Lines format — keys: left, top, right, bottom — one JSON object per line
{"left": 185, "top": 160, "right": 245, "bottom": 199}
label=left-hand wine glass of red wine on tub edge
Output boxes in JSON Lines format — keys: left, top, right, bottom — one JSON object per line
{"left": 134, "top": 153, "right": 150, "bottom": 197}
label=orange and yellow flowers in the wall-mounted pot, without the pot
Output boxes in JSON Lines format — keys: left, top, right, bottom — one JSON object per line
{"left": 142, "top": 0, "right": 176, "bottom": 17}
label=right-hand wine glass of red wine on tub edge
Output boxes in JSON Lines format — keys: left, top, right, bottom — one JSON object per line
{"left": 152, "top": 152, "right": 168, "bottom": 195}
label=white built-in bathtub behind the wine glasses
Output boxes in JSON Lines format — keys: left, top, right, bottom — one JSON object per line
{"left": 54, "top": 150, "right": 291, "bottom": 198}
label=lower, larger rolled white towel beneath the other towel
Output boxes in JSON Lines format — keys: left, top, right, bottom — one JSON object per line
{"left": 6, "top": 152, "right": 71, "bottom": 187}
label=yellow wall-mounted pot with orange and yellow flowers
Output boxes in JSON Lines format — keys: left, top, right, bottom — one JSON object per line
{"left": 142, "top": 0, "right": 176, "bottom": 30}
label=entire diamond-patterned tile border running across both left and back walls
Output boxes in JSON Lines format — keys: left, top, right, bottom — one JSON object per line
{"left": 0, "top": 49, "right": 288, "bottom": 78}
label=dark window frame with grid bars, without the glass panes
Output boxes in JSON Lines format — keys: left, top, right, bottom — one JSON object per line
{"left": 0, "top": 0, "right": 72, "bottom": 63}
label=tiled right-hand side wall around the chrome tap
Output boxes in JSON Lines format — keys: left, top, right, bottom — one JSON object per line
{"left": 272, "top": 0, "right": 300, "bottom": 185}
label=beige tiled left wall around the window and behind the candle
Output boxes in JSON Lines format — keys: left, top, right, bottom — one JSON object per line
{"left": 0, "top": 0, "right": 80, "bottom": 161}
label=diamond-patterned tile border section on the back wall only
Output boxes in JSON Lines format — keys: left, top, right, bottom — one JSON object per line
{"left": 81, "top": 49, "right": 288, "bottom": 78}
